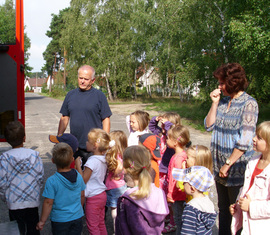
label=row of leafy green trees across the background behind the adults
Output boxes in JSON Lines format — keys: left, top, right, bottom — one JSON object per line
{"left": 45, "top": 0, "right": 270, "bottom": 100}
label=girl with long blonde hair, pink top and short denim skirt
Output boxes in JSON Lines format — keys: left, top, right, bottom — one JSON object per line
{"left": 105, "top": 130, "right": 127, "bottom": 233}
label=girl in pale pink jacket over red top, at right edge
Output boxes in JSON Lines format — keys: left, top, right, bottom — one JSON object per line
{"left": 230, "top": 121, "right": 270, "bottom": 235}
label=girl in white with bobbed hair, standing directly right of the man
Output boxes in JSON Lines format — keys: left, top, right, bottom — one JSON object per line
{"left": 126, "top": 110, "right": 150, "bottom": 146}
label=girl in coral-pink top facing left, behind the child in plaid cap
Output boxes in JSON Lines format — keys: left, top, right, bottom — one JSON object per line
{"left": 164, "top": 125, "right": 190, "bottom": 234}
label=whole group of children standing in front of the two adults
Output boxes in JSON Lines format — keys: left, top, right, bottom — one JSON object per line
{"left": 0, "top": 115, "right": 270, "bottom": 235}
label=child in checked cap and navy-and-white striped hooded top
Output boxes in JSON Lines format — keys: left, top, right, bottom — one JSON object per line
{"left": 172, "top": 166, "right": 217, "bottom": 235}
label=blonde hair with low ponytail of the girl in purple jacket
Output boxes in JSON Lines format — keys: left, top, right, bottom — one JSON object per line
{"left": 123, "top": 146, "right": 152, "bottom": 199}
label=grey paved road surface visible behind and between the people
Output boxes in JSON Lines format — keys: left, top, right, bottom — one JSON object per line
{"left": 0, "top": 93, "right": 217, "bottom": 235}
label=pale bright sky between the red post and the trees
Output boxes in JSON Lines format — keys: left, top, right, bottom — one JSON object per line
{"left": 24, "top": 0, "right": 70, "bottom": 72}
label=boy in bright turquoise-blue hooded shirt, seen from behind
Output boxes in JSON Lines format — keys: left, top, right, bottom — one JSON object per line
{"left": 37, "top": 143, "right": 85, "bottom": 234}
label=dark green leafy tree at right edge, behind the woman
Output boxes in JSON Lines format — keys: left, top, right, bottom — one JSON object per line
{"left": 229, "top": 0, "right": 270, "bottom": 102}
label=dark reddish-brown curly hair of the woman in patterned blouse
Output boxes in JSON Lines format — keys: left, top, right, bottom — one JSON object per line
{"left": 213, "top": 63, "right": 248, "bottom": 94}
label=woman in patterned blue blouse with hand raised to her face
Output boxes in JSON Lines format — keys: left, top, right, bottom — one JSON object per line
{"left": 204, "top": 63, "right": 259, "bottom": 235}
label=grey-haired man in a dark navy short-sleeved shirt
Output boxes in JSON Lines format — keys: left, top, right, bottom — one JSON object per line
{"left": 58, "top": 65, "right": 112, "bottom": 164}
